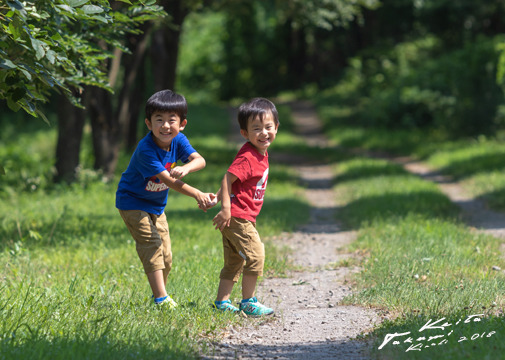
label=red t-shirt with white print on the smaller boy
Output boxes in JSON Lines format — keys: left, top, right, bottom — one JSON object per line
{"left": 228, "top": 142, "right": 268, "bottom": 222}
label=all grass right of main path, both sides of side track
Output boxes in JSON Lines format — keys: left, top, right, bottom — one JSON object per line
{"left": 308, "top": 85, "right": 505, "bottom": 359}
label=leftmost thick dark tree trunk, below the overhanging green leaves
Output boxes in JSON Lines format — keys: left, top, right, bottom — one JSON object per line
{"left": 54, "top": 95, "right": 86, "bottom": 183}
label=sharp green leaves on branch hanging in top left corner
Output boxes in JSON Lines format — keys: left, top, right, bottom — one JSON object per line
{"left": 0, "top": 0, "right": 165, "bottom": 119}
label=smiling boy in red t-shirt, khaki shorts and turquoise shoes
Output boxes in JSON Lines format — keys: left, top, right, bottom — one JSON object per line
{"left": 213, "top": 98, "right": 279, "bottom": 316}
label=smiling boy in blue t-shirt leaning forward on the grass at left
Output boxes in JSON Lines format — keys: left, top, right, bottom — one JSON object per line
{"left": 116, "top": 90, "right": 215, "bottom": 308}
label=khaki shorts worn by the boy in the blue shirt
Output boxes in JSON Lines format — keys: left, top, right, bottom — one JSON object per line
{"left": 119, "top": 210, "right": 172, "bottom": 279}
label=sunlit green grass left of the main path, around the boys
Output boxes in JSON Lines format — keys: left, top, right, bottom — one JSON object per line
{"left": 0, "top": 102, "right": 308, "bottom": 359}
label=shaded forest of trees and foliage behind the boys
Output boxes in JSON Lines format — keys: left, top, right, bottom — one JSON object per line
{"left": 0, "top": 0, "right": 505, "bottom": 184}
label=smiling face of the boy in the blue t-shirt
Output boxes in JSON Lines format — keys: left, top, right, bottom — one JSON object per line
{"left": 145, "top": 111, "right": 188, "bottom": 151}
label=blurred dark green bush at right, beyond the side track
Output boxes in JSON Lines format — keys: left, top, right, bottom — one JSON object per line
{"left": 328, "top": 36, "right": 504, "bottom": 137}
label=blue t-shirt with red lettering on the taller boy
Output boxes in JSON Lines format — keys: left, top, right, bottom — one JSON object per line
{"left": 116, "top": 132, "right": 196, "bottom": 215}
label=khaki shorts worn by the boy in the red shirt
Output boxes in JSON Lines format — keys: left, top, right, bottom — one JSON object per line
{"left": 220, "top": 217, "right": 265, "bottom": 282}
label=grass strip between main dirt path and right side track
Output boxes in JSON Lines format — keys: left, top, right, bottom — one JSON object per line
{"left": 335, "top": 157, "right": 505, "bottom": 359}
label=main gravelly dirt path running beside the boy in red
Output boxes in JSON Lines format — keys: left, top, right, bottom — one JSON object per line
{"left": 201, "top": 104, "right": 381, "bottom": 360}
